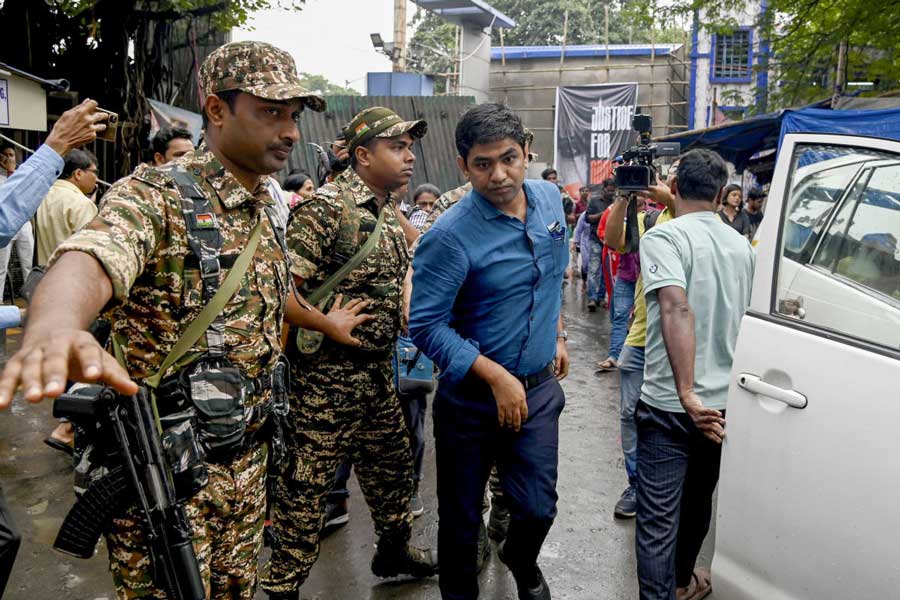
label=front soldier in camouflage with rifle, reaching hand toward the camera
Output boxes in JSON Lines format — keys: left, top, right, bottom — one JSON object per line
{"left": 0, "top": 42, "right": 325, "bottom": 600}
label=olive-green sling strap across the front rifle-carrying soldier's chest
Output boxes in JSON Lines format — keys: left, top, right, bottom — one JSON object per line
{"left": 145, "top": 213, "right": 263, "bottom": 389}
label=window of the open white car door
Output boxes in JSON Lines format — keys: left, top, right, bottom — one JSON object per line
{"left": 772, "top": 145, "right": 900, "bottom": 350}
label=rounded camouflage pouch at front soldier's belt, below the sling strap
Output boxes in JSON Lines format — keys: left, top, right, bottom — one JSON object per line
{"left": 186, "top": 359, "right": 247, "bottom": 453}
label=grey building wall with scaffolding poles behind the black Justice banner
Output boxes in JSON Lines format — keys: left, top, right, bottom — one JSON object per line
{"left": 491, "top": 47, "right": 689, "bottom": 167}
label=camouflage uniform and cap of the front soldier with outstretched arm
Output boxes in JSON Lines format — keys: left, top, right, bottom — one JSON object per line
{"left": 54, "top": 42, "right": 324, "bottom": 600}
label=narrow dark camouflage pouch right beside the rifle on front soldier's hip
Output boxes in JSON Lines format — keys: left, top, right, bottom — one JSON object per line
{"left": 159, "top": 409, "right": 209, "bottom": 500}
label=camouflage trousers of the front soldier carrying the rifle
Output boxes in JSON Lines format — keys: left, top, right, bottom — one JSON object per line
{"left": 106, "top": 445, "right": 267, "bottom": 600}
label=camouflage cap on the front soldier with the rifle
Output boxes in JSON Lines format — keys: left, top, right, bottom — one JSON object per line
{"left": 200, "top": 41, "right": 327, "bottom": 112}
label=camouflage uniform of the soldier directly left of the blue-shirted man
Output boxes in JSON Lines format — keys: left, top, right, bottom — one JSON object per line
{"left": 262, "top": 111, "right": 421, "bottom": 594}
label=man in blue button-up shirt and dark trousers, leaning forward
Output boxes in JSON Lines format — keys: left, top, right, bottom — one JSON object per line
{"left": 410, "top": 104, "right": 569, "bottom": 600}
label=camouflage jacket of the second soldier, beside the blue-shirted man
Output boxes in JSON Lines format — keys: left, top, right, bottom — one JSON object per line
{"left": 285, "top": 168, "right": 409, "bottom": 352}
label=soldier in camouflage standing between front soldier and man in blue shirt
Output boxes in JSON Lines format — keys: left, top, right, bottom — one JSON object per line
{"left": 262, "top": 107, "right": 437, "bottom": 599}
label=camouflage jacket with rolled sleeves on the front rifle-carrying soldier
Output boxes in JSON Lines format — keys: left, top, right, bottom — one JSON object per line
{"left": 53, "top": 145, "right": 289, "bottom": 401}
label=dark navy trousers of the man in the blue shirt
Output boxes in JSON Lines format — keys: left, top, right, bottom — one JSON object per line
{"left": 434, "top": 377, "right": 565, "bottom": 600}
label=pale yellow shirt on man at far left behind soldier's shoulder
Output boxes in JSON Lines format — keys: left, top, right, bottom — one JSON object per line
{"left": 35, "top": 179, "right": 97, "bottom": 266}
